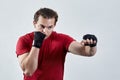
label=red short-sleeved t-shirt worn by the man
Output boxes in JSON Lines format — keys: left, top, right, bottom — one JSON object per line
{"left": 16, "top": 32, "right": 74, "bottom": 80}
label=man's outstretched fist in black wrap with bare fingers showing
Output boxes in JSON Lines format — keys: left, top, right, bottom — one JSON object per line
{"left": 83, "top": 34, "right": 97, "bottom": 47}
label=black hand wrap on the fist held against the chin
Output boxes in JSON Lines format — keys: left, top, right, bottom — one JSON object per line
{"left": 33, "top": 32, "right": 45, "bottom": 48}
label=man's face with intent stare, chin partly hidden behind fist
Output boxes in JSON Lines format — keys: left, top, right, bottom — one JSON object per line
{"left": 33, "top": 16, "right": 55, "bottom": 38}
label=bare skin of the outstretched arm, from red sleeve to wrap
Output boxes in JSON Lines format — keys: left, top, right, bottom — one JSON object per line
{"left": 69, "top": 41, "right": 97, "bottom": 56}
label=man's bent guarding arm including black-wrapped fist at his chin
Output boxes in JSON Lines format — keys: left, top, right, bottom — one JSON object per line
{"left": 18, "top": 31, "right": 45, "bottom": 76}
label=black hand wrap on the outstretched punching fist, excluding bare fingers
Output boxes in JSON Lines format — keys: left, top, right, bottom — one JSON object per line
{"left": 83, "top": 34, "right": 97, "bottom": 47}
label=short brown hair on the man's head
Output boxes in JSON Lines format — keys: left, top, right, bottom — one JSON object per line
{"left": 34, "top": 8, "right": 58, "bottom": 24}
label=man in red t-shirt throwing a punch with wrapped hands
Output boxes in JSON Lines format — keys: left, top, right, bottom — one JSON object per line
{"left": 16, "top": 8, "right": 97, "bottom": 80}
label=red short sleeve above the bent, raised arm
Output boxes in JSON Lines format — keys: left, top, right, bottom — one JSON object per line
{"left": 16, "top": 37, "right": 30, "bottom": 56}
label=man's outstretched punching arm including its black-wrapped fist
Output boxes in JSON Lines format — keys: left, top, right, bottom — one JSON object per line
{"left": 68, "top": 34, "right": 97, "bottom": 56}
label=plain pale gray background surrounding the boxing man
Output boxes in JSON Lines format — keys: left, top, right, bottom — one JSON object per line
{"left": 0, "top": 0, "right": 120, "bottom": 80}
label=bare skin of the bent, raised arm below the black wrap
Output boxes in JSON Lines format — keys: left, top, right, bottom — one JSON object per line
{"left": 18, "top": 47, "right": 40, "bottom": 76}
